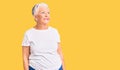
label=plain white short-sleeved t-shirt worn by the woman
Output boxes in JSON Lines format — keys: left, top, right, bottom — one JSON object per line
{"left": 22, "top": 27, "right": 62, "bottom": 70}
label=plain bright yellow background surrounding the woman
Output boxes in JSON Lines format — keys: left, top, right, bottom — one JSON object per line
{"left": 0, "top": 0, "right": 120, "bottom": 70}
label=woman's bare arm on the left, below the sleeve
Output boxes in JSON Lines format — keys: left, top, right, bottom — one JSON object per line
{"left": 22, "top": 46, "right": 30, "bottom": 70}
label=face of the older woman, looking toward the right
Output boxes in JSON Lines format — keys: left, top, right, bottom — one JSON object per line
{"left": 36, "top": 6, "right": 50, "bottom": 24}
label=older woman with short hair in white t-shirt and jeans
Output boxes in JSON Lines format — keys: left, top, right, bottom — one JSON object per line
{"left": 22, "top": 3, "right": 65, "bottom": 70}
